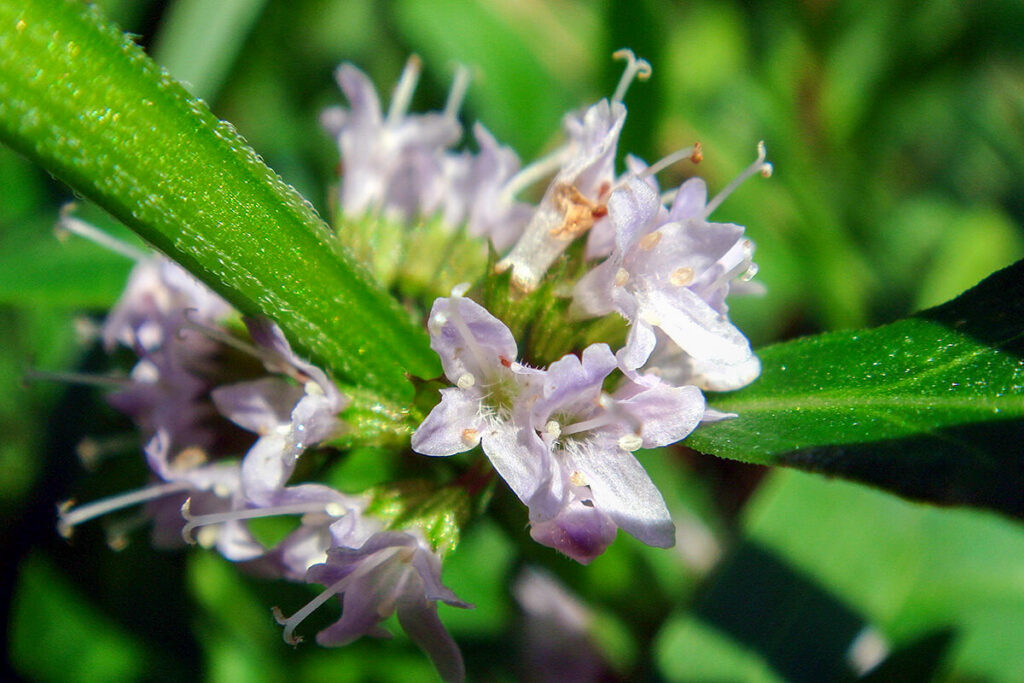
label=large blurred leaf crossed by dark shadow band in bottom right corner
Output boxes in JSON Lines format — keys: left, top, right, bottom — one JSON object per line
{"left": 655, "top": 470, "right": 1024, "bottom": 681}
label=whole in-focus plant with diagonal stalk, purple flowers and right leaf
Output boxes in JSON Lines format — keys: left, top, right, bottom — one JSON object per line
{"left": 0, "top": 2, "right": 1024, "bottom": 680}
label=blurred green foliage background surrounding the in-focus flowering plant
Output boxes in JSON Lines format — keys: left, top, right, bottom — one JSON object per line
{"left": 0, "top": 0, "right": 1024, "bottom": 681}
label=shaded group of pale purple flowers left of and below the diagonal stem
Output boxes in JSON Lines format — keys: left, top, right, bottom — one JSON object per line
{"left": 59, "top": 242, "right": 469, "bottom": 679}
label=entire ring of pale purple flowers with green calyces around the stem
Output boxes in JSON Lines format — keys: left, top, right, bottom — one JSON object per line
{"left": 51, "top": 50, "right": 771, "bottom": 680}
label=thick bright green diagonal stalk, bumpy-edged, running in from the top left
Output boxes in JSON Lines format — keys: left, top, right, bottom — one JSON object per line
{"left": 0, "top": 0, "right": 440, "bottom": 397}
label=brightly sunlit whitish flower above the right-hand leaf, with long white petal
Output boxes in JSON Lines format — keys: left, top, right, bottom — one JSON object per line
{"left": 573, "top": 172, "right": 760, "bottom": 390}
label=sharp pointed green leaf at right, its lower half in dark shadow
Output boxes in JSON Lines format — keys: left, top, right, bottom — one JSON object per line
{"left": 687, "top": 261, "right": 1024, "bottom": 516}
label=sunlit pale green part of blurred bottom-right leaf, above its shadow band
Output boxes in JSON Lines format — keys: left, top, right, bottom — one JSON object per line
{"left": 738, "top": 471, "right": 1024, "bottom": 681}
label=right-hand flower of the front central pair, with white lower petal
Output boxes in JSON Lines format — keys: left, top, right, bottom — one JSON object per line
{"left": 517, "top": 344, "right": 705, "bottom": 563}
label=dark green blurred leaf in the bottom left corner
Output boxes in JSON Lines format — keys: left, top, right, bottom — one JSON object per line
{"left": 8, "top": 557, "right": 147, "bottom": 683}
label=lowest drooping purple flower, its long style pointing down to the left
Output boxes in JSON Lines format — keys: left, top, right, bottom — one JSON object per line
{"left": 274, "top": 530, "right": 470, "bottom": 681}
